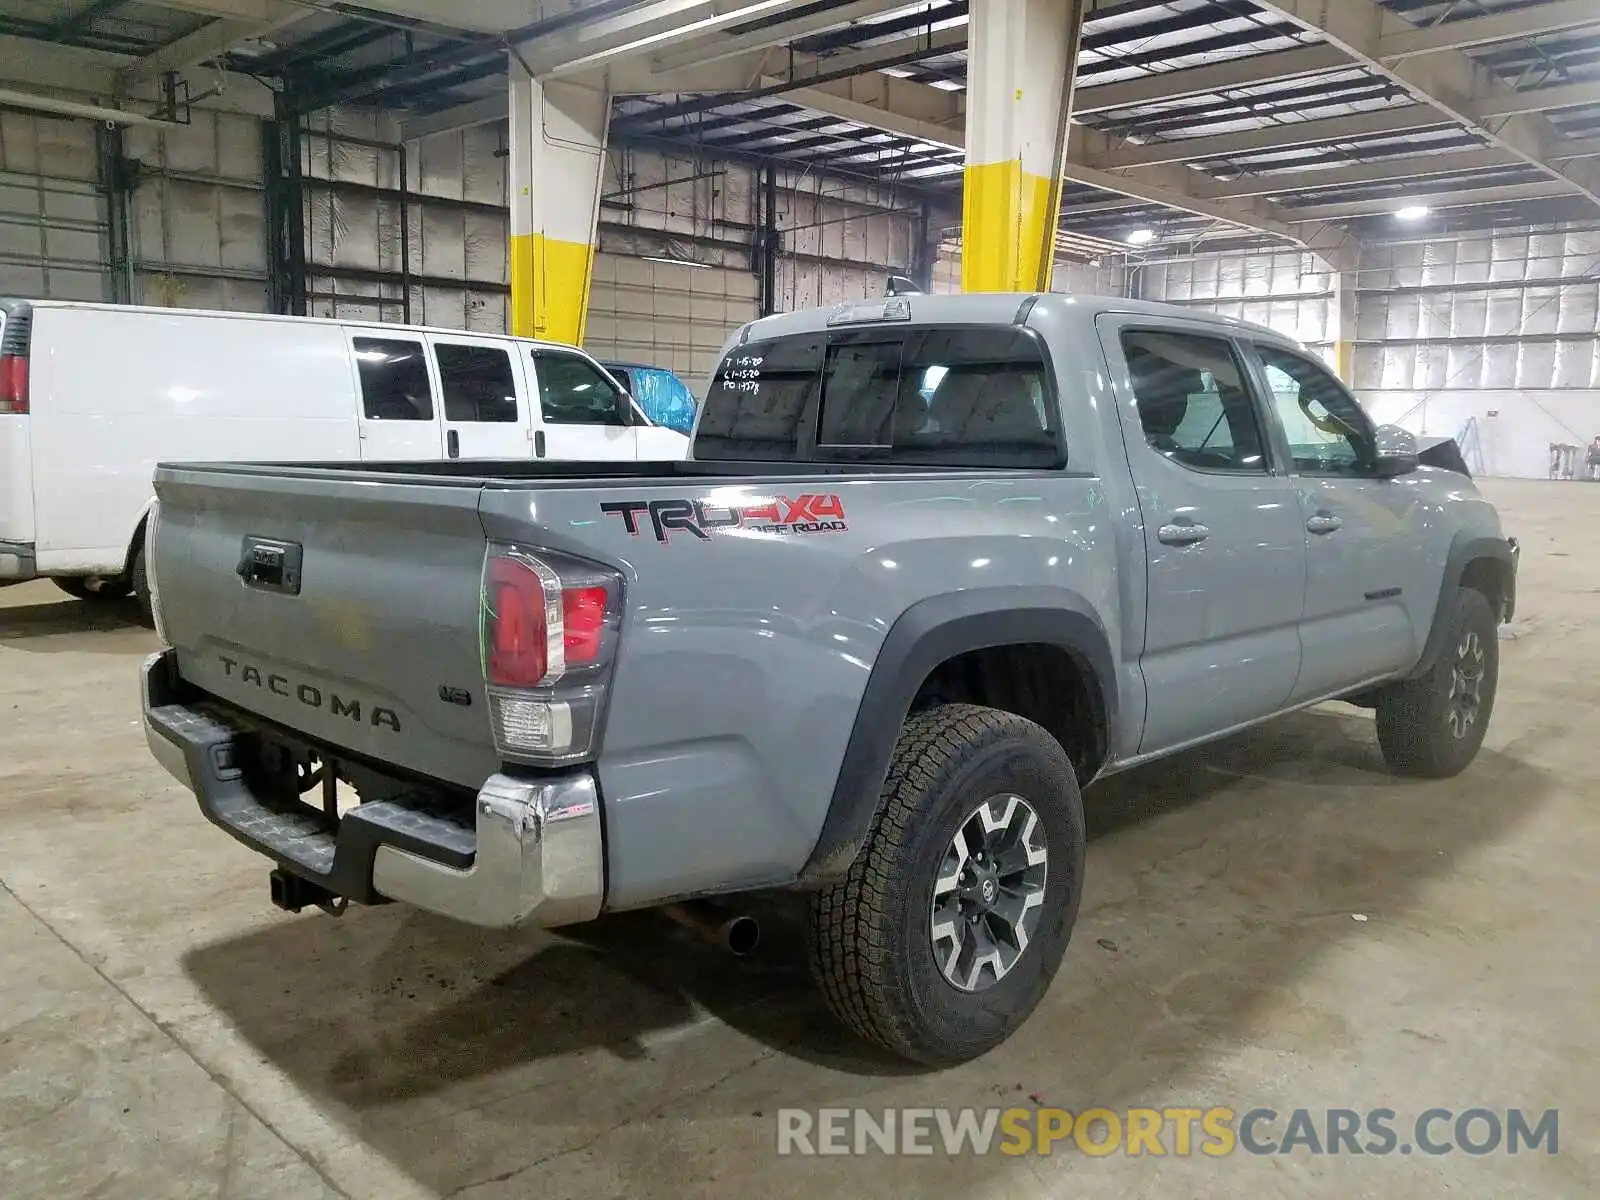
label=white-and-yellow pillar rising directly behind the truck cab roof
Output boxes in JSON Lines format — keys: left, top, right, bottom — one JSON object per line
{"left": 962, "top": 0, "right": 1088, "bottom": 291}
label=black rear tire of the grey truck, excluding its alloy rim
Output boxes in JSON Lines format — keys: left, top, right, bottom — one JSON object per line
{"left": 810, "top": 704, "right": 1085, "bottom": 1066}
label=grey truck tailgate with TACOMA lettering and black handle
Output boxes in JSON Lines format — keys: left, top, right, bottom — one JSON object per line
{"left": 150, "top": 467, "right": 498, "bottom": 787}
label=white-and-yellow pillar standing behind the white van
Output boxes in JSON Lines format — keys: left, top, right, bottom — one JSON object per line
{"left": 510, "top": 56, "right": 611, "bottom": 346}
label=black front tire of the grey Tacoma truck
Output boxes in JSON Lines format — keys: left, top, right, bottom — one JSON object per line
{"left": 1378, "top": 587, "right": 1499, "bottom": 779}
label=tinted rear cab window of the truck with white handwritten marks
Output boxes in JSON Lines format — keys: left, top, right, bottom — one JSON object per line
{"left": 694, "top": 325, "right": 1066, "bottom": 467}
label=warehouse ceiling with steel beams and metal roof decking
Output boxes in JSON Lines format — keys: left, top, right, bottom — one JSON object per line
{"left": 0, "top": 0, "right": 1600, "bottom": 256}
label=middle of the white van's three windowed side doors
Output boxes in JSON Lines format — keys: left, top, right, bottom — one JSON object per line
{"left": 429, "top": 333, "right": 533, "bottom": 459}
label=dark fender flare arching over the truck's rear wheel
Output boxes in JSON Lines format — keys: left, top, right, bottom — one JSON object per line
{"left": 800, "top": 587, "right": 1117, "bottom": 883}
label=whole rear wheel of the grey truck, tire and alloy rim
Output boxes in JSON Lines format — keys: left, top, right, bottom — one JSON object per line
{"left": 811, "top": 704, "right": 1085, "bottom": 1066}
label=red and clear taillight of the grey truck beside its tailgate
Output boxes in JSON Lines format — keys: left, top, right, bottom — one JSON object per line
{"left": 482, "top": 544, "right": 622, "bottom": 765}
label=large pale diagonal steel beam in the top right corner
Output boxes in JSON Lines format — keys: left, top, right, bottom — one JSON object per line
{"left": 1259, "top": 0, "right": 1600, "bottom": 205}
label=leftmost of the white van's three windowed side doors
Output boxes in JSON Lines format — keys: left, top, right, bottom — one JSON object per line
{"left": 346, "top": 326, "right": 445, "bottom": 462}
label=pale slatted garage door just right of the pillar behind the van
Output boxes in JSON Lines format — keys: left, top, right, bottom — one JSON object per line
{"left": 584, "top": 253, "right": 760, "bottom": 395}
